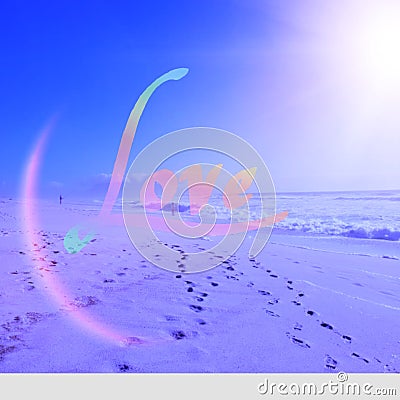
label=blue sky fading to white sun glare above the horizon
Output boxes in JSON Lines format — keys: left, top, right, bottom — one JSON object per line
{"left": 0, "top": 0, "right": 400, "bottom": 195}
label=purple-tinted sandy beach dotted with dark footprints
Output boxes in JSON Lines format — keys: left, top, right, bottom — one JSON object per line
{"left": 0, "top": 199, "right": 400, "bottom": 373}
